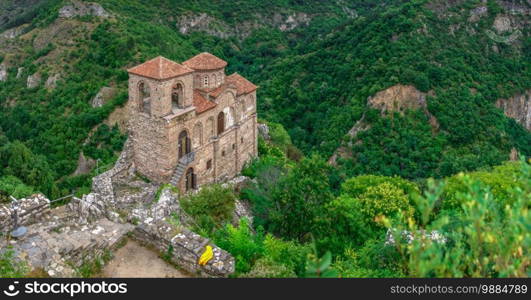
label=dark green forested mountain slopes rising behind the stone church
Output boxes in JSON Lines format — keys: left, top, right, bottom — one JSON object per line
{"left": 0, "top": 0, "right": 531, "bottom": 199}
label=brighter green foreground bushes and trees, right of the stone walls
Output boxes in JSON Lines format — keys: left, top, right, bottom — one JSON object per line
{"left": 176, "top": 130, "right": 531, "bottom": 277}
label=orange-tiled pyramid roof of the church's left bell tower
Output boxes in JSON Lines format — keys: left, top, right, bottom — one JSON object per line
{"left": 127, "top": 56, "right": 194, "bottom": 80}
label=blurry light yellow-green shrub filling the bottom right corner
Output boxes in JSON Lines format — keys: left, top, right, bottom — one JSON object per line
{"left": 394, "top": 162, "right": 531, "bottom": 277}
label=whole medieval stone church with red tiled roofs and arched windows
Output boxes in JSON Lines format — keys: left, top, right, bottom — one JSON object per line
{"left": 127, "top": 53, "right": 257, "bottom": 192}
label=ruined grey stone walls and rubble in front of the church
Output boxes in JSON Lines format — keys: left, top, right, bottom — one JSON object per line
{"left": 0, "top": 136, "right": 241, "bottom": 277}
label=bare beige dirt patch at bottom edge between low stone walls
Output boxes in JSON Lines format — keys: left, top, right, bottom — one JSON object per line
{"left": 103, "top": 240, "right": 191, "bottom": 278}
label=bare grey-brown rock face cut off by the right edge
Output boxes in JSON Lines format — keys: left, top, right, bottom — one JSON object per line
{"left": 496, "top": 90, "right": 531, "bottom": 130}
